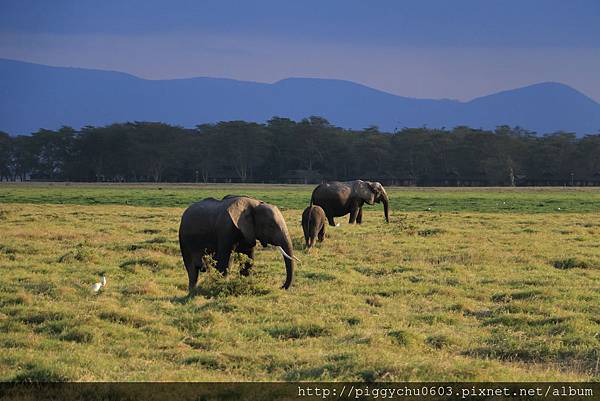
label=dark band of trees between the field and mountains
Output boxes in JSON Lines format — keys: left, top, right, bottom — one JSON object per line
{"left": 0, "top": 117, "right": 600, "bottom": 186}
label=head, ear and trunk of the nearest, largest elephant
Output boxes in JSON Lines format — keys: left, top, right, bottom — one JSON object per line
{"left": 227, "top": 197, "right": 294, "bottom": 289}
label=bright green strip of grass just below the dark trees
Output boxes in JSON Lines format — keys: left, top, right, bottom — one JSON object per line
{"left": 0, "top": 183, "right": 600, "bottom": 213}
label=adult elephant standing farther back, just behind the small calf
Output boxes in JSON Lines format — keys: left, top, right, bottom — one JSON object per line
{"left": 310, "top": 180, "right": 390, "bottom": 226}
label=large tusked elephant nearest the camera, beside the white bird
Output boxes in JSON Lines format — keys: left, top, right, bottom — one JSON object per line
{"left": 179, "top": 195, "right": 294, "bottom": 292}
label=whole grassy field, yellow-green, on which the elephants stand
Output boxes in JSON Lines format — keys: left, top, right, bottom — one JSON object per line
{"left": 0, "top": 184, "right": 600, "bottom": 381}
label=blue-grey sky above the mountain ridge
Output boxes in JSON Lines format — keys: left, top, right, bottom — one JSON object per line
{"left": 0, "top": 0, "right": 600, "bottom": 101}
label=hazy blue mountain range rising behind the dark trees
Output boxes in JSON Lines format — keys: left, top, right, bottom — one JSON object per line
{"left": 0, "top": 59, "right": 600, "bottom": 135}
